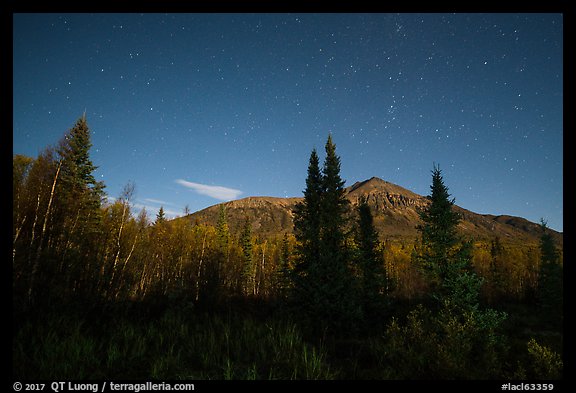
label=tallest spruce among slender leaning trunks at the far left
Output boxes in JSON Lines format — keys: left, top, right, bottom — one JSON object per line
{"left": 29, "top": 115, "right": 104, "bottom": 304}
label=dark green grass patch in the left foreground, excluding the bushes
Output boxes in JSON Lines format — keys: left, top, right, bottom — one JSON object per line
{"left": 13, "top": 313, "right": 335, "bottom": 380}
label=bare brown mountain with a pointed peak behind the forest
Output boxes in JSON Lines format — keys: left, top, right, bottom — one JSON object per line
{"left": 178, "top": 177, "right": 563, "bottom": 245}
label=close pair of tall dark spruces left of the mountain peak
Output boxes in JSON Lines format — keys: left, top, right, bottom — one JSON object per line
{"left": 293, "top": 136, "right": 360, "bottom": 331}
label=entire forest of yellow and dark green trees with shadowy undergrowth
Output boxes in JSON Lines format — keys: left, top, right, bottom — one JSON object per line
{"left": 12, "top": 116, "right": 563, "bottom": 379}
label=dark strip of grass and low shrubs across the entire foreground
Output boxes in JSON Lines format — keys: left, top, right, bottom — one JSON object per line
{"left": 12, "top": 298, "right": 563, "bottom": 380}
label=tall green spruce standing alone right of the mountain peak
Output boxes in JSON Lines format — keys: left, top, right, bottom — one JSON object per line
{"left": 419, "top": 166, "right": 506, "bottom": 378}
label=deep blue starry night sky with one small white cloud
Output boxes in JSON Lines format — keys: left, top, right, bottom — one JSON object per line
{"left": 13, "top": 13, "right": 563, "bottom": 231}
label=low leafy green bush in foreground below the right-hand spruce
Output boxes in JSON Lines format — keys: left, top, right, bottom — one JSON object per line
{"left": 372, "top": 306, "right": 507, "bottom": 379}
